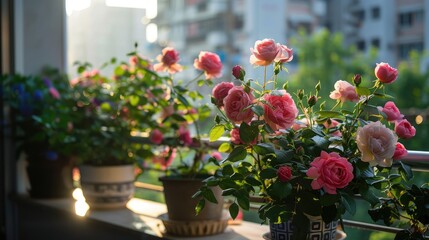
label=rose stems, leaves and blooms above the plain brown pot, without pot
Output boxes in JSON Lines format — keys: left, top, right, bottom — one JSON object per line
{"left": 146, "top": 47, "right": 222, "bottom": 177}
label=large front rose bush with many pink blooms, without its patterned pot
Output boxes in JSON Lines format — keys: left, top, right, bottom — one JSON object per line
{"left": 196, "top": 39, "right": 429, "bottom": 239}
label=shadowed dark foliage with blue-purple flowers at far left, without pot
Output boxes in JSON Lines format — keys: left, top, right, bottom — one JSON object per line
{"left": 0, "top": 68, "right": 76, "bottom": 165}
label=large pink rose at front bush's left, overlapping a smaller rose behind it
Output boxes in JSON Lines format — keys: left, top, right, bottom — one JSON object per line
{"left": 223, "top": 86, "right": 253, "bottom": 123}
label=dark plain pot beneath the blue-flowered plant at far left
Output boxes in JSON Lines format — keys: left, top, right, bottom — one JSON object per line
{"left": 26, "top": 159, "right": 73, "bottom": 198}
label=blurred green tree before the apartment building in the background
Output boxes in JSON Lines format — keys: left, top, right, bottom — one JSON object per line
{"left": 289, "top": 29, "right": 377, "bottom": 102}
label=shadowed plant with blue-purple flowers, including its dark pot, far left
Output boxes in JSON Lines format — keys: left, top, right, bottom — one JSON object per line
{"left": 1, "top": 68, "right": 75, "bottom": 198}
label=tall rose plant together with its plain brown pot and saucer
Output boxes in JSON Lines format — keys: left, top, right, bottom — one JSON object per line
{"left": 140, "top": 47, "right": 227, "bottom": 236}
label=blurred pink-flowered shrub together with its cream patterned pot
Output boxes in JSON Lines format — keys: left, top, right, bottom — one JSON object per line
{"left": 71, "top": 53, "right": 159, "bottom": 209}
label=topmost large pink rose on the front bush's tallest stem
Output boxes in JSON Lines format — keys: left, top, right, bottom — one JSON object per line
{"left": 250, "top": 39, "right": 281, "bottom": 66}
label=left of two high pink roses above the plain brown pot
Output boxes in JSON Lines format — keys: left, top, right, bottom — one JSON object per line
{"left": 153, "top": 47, "right": 182, "bottom": 74}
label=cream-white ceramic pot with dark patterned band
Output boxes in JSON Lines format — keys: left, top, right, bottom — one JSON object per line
{"left": 79, "top": 164, "right": 135, "bottom": 209}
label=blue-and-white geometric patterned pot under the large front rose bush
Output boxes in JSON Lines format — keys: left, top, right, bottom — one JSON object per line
{"left": 270, "top": 217, "right": 338, "bottom": 240}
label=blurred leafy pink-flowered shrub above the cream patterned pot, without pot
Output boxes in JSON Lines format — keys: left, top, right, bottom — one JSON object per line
{"left": 70, "top": 52, "right": 161, "bottom": 165}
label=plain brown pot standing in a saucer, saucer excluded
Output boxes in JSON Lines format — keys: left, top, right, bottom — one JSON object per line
{"left": 160, "top": 177, "right": 223, "bottom": 221}
